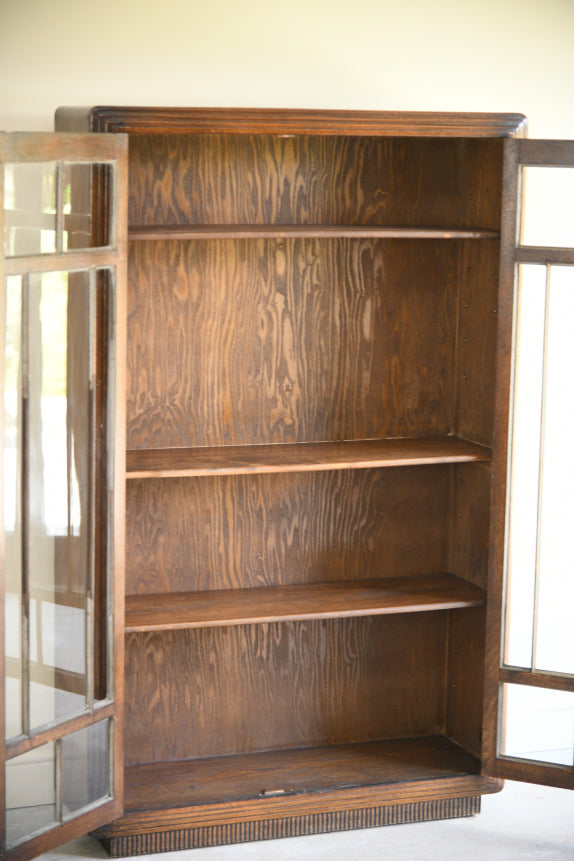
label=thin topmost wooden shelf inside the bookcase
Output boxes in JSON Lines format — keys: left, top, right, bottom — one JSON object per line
{"left": 128, "top": 224, "right": 500, "bottom": 241}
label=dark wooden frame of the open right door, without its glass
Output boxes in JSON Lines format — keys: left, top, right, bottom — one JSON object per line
{"left": 482, "top": 139, "right": 574, "bottom": 789}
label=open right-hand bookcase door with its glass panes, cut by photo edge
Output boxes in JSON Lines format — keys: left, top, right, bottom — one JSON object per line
{"left": 484, "top": 140, "right": 574, "bottom": 788}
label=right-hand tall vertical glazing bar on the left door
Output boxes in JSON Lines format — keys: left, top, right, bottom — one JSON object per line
{"left": 86, "top": 268, "right": 98, "bottom": 709}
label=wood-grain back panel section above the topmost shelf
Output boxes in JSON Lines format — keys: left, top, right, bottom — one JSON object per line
{"left": 129, "top": 134, "right": 470, "bottom": 227}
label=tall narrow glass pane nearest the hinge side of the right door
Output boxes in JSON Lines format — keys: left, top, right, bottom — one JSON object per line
{"left": 504, "top": 266, "right": 546, "bottom": 668}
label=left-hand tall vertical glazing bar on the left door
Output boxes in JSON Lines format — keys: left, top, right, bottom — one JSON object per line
{"left": 20, "top": 275, "right": 30, "bottom": 735}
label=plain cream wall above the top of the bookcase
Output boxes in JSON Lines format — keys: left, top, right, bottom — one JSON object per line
{"left": 0, "top": 0, "right": 574, "bottom": 138}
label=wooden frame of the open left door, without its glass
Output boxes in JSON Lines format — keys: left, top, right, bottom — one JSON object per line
{"left": 0, "top": 133, "right": 127, "bottom": 861}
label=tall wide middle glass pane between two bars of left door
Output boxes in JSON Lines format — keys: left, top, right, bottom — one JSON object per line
{"left": 28, "top": 272, "right": 91, "bottom": 729}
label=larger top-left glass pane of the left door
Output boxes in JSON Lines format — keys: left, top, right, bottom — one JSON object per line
{"left": 4, "top": 162, "right": 56, "bottom": 257}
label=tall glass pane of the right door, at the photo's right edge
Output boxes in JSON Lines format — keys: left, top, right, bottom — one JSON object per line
{"left": 534, "top": 266, "right": 574, "bottom": 674}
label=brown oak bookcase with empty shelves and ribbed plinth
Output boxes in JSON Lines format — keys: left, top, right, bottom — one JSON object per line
{"left": 1, "top": 107, "right": 574, "bottom": 858}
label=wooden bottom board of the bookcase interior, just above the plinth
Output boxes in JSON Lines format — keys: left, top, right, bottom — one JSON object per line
{"left": 125, "top": 736, "right": 486, "bottom": 814}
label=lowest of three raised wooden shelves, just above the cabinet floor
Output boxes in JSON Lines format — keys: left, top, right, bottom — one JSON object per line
{"left": 125, "top": 574, "right": 485, "bottom": 632}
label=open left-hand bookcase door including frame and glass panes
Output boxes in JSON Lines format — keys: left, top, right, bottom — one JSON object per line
{"left": 0, "top": 134, "right": 127, "bottom": 859}
